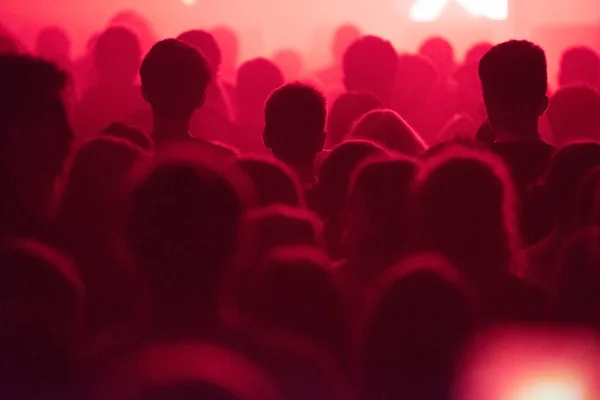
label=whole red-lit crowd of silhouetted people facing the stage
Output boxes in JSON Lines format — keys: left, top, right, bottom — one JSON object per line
{"left": 0, "top": 12, "right": 600, "bottom": 400}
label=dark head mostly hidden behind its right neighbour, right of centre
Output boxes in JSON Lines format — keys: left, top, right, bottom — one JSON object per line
{"left": 317, "top": 140, "right": 387, "bottom": 260}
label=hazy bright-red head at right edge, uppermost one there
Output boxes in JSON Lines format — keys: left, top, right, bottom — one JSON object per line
{"left": 558, "top": 46, "right": 600, "bottom": 89}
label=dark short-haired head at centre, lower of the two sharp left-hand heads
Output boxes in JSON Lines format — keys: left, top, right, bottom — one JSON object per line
{"left": 265, "top": 82, "right": 327, "bottom": 164}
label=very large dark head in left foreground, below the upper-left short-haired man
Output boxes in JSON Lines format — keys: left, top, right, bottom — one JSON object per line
{"left": 129, "top": 160, "right": 246, "bottom": 322}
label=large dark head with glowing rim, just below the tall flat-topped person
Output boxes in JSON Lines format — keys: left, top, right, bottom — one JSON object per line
{"left": 419, "top": 146, "right": 517, "bottom": 281}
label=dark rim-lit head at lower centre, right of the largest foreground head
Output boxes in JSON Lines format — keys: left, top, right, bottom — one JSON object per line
{"left": 242, "top": 247, "right": 349, "bottom": 360}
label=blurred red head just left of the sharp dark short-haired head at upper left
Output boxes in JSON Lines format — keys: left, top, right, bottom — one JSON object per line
{"left": 94, "top": 26, "right": 142, "bottom": 84}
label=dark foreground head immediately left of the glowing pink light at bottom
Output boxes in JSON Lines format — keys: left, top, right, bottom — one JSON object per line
{"left": 361, "top": 255, "right": 474, "bottom": 399}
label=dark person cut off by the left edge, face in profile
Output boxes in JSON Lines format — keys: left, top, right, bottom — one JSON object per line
{"left": 0, "top": 54, "right": 73, "bottom": 241}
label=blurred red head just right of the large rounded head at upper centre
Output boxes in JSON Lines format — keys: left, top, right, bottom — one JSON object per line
{"left": 392, "top": 54, "right": 438, "bottom": 120}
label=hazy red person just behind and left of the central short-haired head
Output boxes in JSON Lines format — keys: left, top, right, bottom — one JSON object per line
{"left": 235, "top": 58, "right": 285, "bottom": 153}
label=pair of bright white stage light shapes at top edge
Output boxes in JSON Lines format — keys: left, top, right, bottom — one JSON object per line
{"left": 401, "top": 0, "right": 508, "bottom": 22}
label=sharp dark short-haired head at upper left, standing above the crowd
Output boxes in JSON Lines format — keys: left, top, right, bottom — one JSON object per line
{"left": 140, "top": 39, "right": 212, "bottom": 117}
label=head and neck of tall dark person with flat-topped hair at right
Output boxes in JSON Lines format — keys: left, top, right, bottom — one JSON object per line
{"left": 479, "top": 40, "right": 554, "bottom": 186}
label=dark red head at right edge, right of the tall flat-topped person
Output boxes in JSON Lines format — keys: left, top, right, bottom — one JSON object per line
{"left": 547, "top": 86, "right": 600, "bottom": 146}
